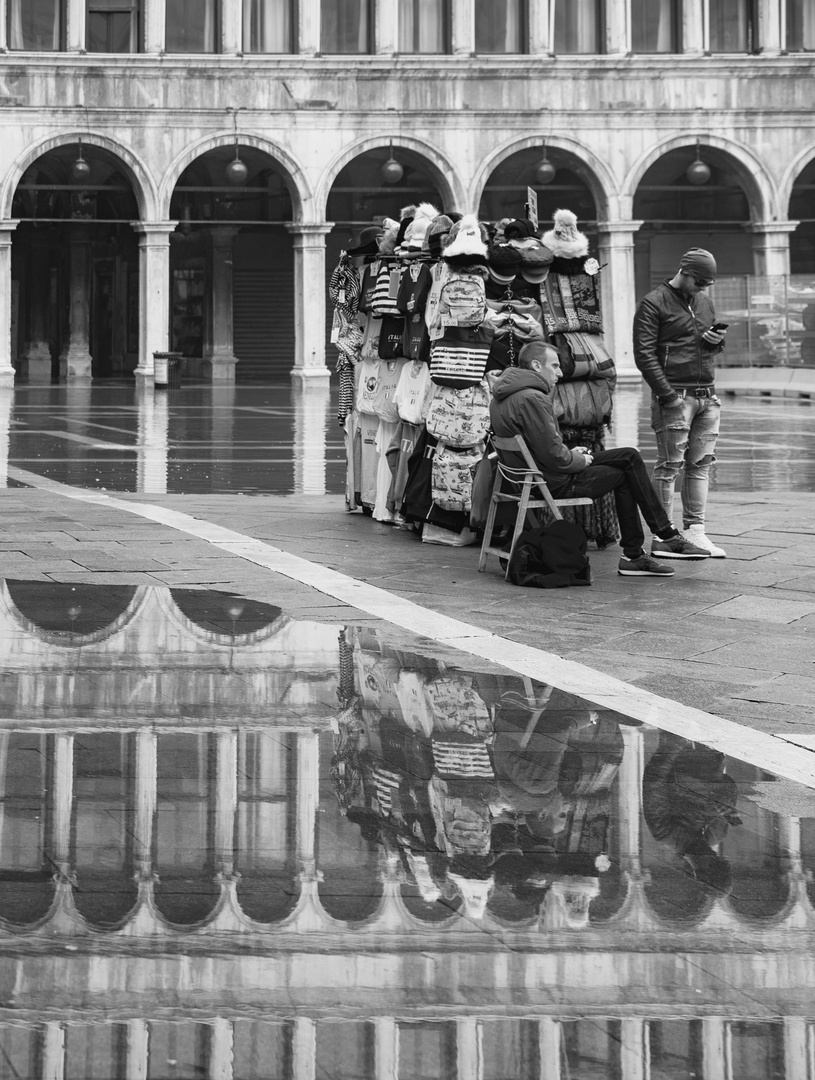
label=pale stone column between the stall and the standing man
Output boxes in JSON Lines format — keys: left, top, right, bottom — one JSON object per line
{"left": 597, "top": 220, "right": 642, "bottom": 382}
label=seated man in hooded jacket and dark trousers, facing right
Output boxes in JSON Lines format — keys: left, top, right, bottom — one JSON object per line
{"left": 490, "top": 341, "right": 709, "bottom": 578}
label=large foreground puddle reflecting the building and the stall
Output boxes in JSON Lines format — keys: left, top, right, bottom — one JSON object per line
{"left": 0, "top": 581, "right": 815, "bottom": 1080}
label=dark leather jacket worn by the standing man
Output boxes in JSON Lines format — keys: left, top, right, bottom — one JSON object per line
{"left": 634, "top": 281, "right": 723, "bottom": 402}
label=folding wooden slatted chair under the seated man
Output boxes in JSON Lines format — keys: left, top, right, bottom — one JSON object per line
{"left": 478, "top": 435, "right": 593, "bottom": 578}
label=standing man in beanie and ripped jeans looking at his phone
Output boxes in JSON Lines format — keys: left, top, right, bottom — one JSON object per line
{"left": 634, "top": 247, "right": 726, "bottom": 558}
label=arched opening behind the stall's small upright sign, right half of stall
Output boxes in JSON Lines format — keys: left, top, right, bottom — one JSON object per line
{"left": 478, "top": 140, "right": 597, "bottom": 241}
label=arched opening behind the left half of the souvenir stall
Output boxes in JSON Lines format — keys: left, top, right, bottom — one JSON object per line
{"left": 326, "top": 144, "right": 446, "bottom": 366}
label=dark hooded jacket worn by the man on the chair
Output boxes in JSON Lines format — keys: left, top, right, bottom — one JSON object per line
{"left": 490, "top": 367, "right": 588, "bottom": 480}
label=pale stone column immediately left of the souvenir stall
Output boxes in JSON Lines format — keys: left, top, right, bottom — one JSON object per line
{"left": 286, "top": 221, "right": 332, "bottom": 386}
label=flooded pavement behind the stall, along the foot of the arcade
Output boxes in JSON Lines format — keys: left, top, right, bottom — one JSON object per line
{"left": 0, "top": 382, "right": 815, "bottom": 495}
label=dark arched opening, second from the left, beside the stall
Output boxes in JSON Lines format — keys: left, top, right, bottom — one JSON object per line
{"left": 169, "top": 140, "right": 295, "bottom": 381}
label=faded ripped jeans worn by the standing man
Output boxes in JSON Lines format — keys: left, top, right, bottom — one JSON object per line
{"left": 651, "top": 391, "right": 721, "bottom": 528}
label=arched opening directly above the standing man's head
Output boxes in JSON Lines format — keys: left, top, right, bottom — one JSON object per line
{"left": 634, "top": 146, "right": 753, "bottom": 298}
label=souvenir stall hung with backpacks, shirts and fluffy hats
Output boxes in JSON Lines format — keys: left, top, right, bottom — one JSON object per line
{"left": 329, "top": 203, "right": 617, "bottom": 546}
